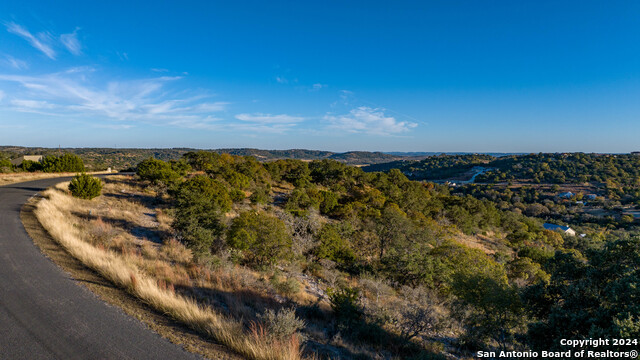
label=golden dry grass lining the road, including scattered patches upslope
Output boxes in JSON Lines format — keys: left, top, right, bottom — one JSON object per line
{"left": 36, "top": 183, "right": 310, "bottom": 360}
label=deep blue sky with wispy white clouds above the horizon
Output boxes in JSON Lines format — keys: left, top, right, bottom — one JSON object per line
{"left": 0, "top": 0, "right": 640, "bottom": 152}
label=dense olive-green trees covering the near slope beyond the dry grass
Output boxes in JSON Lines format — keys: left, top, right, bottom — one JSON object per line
{"left": 127, "top": 152, "right": 636, "bottom": 358}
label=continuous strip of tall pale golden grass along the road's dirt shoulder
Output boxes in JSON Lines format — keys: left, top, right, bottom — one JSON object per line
{"left": 35, "top": 183, "right": 302, "bottom": 360}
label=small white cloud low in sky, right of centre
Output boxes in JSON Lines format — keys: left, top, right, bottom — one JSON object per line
{"left": 324, "top": 106, "right": 417, "bottom": 135}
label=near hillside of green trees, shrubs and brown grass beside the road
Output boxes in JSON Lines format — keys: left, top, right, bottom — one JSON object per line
{"left": 36, "top": 152, "right": 640, "bottom": 359}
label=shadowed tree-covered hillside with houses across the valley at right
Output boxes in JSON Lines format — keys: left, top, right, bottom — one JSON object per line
{"left": 365, "top": 153, "right": 640, "bottom": 232}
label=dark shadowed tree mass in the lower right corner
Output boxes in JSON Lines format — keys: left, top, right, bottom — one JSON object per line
{"left": 523, "top": 237, "right": 640, "bottom": 352}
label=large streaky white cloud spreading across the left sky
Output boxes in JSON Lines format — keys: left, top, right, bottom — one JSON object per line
{"left": 0, "top": 67, "right": 228, "bottom": 129}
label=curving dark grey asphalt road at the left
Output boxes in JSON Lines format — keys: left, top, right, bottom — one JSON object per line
{"left": 0, "top": 178, "right": 197, "bottom": 360}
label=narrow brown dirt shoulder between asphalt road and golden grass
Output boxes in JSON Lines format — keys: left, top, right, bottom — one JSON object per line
{"left": 20, "top": 197, "right": 242, "bottom": 359}
